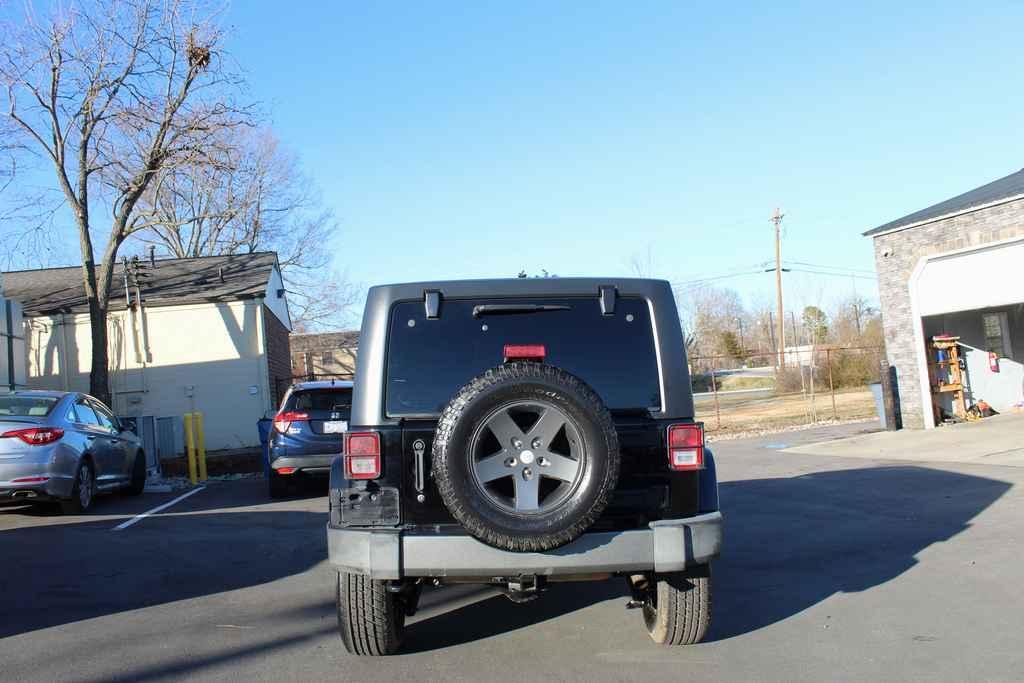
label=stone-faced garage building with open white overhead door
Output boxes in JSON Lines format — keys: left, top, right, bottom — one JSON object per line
{"left": 864, "top": 170, "right": 1024, "bottom": 427}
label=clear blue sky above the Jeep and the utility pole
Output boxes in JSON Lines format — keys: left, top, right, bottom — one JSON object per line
{"left": 12, "top": 1, "right": 1024, "bottom": 321}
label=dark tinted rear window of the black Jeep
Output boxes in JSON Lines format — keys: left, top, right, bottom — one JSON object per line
{"left": 385, "top": 297, "right": 660, "bottom": 417}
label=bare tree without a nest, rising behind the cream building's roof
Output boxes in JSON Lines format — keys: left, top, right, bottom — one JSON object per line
{"left": 130, "top": 129, "right": 359, "bottom": 330}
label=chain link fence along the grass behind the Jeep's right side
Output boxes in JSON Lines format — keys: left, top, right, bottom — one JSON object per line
{"left": 690, "top": 345, "right": 885, "bottom": 435}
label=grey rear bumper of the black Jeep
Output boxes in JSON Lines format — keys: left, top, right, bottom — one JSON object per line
{"left": 327, "top": 512, "right": 722, "bottom": 580}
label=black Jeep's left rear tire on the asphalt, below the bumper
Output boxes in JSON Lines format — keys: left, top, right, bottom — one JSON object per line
{"left": 337, "top": 571, "right": 406, "bottom": 656}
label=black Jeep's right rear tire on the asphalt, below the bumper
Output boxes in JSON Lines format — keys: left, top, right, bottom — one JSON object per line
{"left": 643, "top": 567, "right": 712, "bottom": 645}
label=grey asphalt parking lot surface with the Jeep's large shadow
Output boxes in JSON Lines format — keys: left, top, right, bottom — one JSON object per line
{"left": 0, "top": 425, "right": 1024, "bottom": 681}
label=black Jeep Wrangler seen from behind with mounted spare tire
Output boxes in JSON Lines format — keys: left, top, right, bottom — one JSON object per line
{"left": 328, "top": 279, "right": 722, "bottom": 655}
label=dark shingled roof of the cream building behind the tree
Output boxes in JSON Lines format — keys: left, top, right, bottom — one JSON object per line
{"left": 3, "top": 252, "right": 278, "bottom": 315}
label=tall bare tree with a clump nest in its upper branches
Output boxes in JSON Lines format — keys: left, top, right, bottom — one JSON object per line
{"left": 0, "top": 0, "right": 249, "bottom": 401}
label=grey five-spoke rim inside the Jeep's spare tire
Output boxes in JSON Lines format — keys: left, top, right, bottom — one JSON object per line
{"left": 469, "top": 400, "right": 585, "bottom": 515}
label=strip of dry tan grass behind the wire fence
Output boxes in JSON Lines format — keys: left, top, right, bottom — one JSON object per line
{"left": 696, "top": 389, "right": 876, "bottom": 433}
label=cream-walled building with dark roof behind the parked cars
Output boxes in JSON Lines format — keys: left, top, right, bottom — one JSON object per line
{"left": 3, "top": 252, "right": 292, "bottom": 451}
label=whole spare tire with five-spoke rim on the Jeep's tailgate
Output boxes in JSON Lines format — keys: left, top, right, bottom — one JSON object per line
{"left": 431, "top": 361, "right": 620, "bottom": 552}
